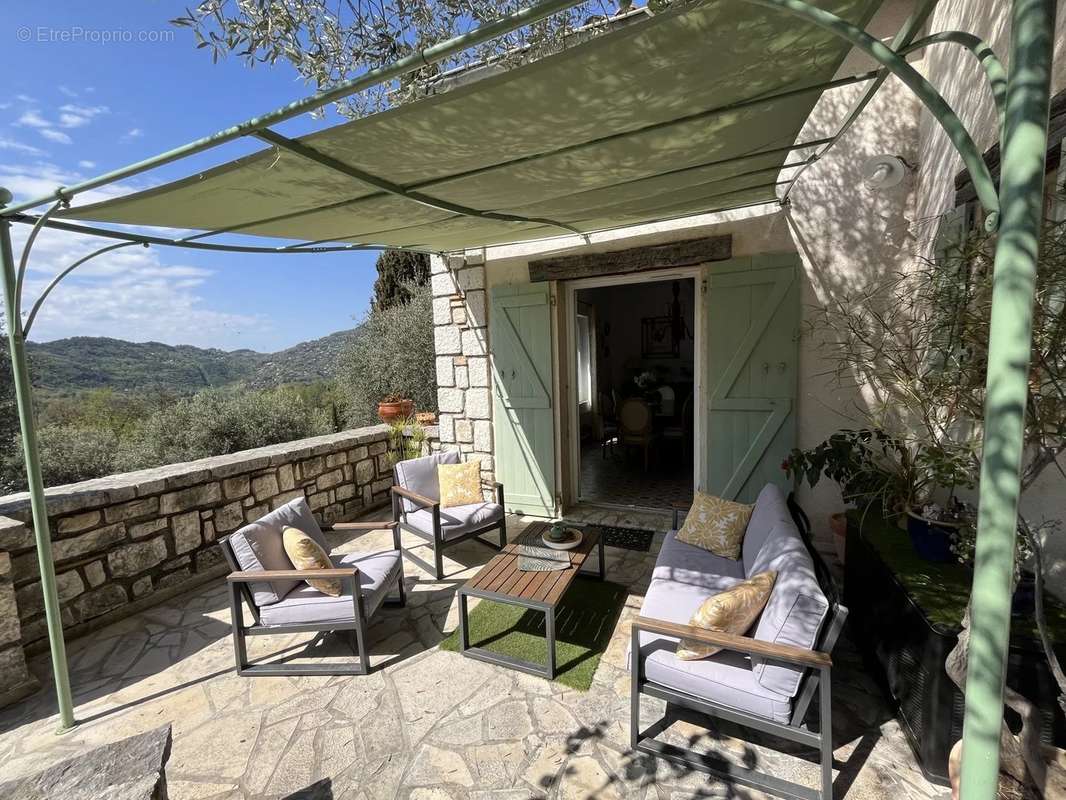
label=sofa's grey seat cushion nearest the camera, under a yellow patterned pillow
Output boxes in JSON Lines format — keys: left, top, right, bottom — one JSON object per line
{"left": 627, "top": 578, "right": 792, "bottom": 723}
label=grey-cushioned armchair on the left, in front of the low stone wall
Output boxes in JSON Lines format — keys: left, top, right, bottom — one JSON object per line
{"left": 220, "top": 497, "right": 406, "bottom": 675}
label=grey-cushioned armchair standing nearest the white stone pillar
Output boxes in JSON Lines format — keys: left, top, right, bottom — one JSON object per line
{"left": 392, "top": 451, "right": 507, "bottom": 580}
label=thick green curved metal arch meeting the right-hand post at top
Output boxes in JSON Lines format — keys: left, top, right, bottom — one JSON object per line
{"left": 743, "top": 0, "right": 1000, "bottom": 230}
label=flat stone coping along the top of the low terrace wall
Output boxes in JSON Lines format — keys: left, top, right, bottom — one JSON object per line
{"left": 0, "top": 425, "right": 437, "bottom": 522}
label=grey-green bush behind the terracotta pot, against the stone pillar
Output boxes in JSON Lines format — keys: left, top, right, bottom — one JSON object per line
{"left": 338, "top": 286, "right": 437, "bottom": 427}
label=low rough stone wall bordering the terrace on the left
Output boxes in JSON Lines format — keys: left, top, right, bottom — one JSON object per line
{"left": 0, "top": 426, "right": 437, "bottom": 699}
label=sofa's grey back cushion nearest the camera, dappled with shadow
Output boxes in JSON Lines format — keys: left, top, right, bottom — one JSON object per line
{"left": 750, "top": 519, "right": 829, "bottom": 698}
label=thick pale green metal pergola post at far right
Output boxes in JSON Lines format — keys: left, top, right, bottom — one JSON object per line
{"left": 962, "top": 0, "right": 1055, "bottom": 800}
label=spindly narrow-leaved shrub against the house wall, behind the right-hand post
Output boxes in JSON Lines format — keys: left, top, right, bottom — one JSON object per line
{"left": 812, "top": 213, "right": 1066, "bottom": 788}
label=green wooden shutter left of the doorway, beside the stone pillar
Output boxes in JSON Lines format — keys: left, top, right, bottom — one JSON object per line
{"left": 489, "top": 285, "right": 555, "bottom": 516}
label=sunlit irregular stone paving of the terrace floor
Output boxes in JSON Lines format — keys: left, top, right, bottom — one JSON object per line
{"left": 0, "top": 512, "right": 949, "bottom": 800}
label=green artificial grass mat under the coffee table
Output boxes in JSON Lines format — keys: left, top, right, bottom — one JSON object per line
{"left": 440, "top": 578, "right": 628, "bottom": 691}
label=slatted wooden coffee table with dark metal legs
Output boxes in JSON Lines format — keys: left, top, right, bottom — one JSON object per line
{"left": 459, "top": 523, "right": 607, "bottom": 681}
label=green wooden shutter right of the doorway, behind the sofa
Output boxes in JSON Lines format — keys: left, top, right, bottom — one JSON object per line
{"left": 704, "top": 255, "right": 800, "bottom": 502}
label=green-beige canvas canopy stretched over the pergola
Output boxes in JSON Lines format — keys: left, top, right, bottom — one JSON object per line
{"left": 58, "top": 0, "right": 878, "bottom": 251}
